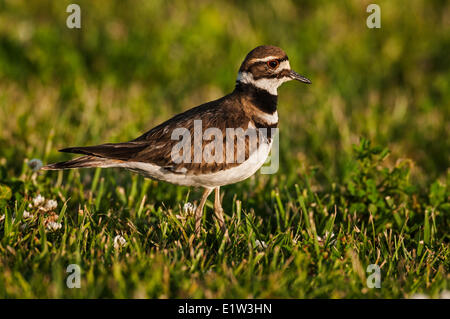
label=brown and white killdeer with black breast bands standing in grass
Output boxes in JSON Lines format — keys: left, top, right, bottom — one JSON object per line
{"left": 43, "top": 46, "right": 311, "bottom": 234}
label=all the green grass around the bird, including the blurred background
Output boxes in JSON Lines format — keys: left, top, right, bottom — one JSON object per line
{"left": 0, "top": 0, "right": 450, "bottom": 298}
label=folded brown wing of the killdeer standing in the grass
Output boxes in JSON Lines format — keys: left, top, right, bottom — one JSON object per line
{"left": 55, "top": 95, "right": 268, "bottom": 174}
